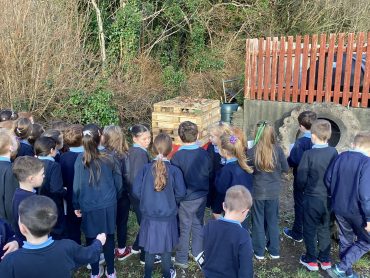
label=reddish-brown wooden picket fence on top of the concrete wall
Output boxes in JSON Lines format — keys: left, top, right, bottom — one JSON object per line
{"left": 245, "top": 32, "right": 370, "bottom": 107}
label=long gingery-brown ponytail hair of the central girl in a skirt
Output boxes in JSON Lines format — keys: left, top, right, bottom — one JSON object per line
{"left": 153, "top": 133, "right": 172, "bottom": 191}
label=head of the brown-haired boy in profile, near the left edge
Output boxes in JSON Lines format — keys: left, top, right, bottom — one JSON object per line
{"left": 13, "top": 156, "right": 44, "bottom": 187}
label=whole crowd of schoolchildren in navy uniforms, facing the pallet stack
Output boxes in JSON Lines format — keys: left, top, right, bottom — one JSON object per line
{"left": 0, "top": 110, "right": 370, "bottom": 278}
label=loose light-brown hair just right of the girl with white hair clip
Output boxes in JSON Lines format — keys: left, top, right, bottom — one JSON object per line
{"left": 103, "top": 125, "right": 128, "bottom": 157}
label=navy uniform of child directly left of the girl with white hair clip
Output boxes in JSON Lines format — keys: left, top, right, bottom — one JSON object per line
{"left": 60, "top": 147, "right": 83, "bottom": 244}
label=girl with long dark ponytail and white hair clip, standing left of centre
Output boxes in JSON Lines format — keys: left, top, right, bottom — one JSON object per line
{"left": 73, "top": 124, "right": 122, "bottom": 278}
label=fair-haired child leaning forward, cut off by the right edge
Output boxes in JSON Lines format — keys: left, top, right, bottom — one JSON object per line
{"left": 325, "top": 132, "right": 370, "bottom": 278}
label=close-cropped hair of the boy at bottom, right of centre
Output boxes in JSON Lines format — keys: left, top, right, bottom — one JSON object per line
{"left": 224, "top": 185, "right": 253, "bottom": 211}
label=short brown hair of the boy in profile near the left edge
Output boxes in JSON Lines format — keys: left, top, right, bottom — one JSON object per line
{"left": 13, "top": 156, "right": 44, "bottom": 182}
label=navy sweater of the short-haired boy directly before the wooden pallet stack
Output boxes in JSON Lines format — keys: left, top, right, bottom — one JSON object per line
{"left": 171, "top": 144, "right": 213, "bottom": 201}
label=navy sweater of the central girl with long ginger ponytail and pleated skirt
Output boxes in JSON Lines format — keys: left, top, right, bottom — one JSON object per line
{"left": 133, "top": 161, "right": 186, "bottom": 220}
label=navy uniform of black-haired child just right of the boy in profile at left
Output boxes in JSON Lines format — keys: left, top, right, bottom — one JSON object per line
{"left": 38, "top": 156, "right": 67, "bottom": 239}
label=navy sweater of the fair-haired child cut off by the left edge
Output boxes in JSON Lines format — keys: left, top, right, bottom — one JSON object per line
{"left": 0, "top": 157, "right": 19, "bottom": 223}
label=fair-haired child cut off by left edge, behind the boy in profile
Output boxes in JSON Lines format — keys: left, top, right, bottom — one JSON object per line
{"left": 0, "top": 129, "right": 19, "bottom": 223}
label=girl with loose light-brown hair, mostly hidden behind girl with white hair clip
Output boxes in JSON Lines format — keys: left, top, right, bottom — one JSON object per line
{"left": 102, "top": 125, "right": 132, "bottom": 261}
